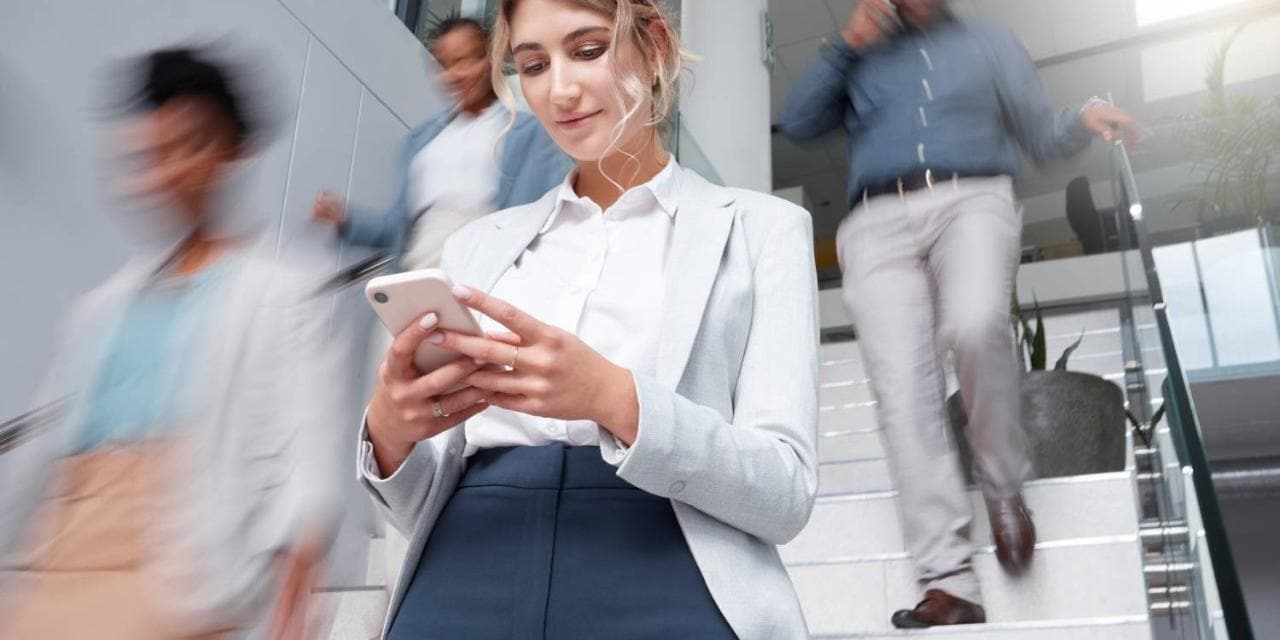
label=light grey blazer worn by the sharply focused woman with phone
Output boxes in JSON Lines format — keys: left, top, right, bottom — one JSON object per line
{"left": 360, "top": 169, "right": 818, "bottom": 640}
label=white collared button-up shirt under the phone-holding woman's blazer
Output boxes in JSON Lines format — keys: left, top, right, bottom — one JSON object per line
{"left": 465, "top": 159, "right": 680, "bottom": 456}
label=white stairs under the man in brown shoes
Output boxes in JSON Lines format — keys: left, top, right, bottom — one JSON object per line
{"left": 781, "top": 342, "right": 1152, "bottom": 640}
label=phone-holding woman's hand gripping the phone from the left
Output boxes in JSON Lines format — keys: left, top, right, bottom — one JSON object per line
{"left": 365, "top": 314, "right": 489, "bottom": 477}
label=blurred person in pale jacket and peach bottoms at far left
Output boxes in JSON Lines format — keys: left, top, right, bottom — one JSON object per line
{"left": 0, "top": 49, "right": 342, "bottom": 640}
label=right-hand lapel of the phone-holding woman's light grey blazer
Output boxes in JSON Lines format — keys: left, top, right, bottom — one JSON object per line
{"left": 657, "top": 169, "right": 733, "bottom": 388}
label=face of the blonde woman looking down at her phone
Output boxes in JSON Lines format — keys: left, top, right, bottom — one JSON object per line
{"left": 511, "top": 0, "right": 653, "bottom": 163}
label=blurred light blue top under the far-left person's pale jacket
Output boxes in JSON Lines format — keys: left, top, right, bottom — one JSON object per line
{"left": 73, "top": 257, "right": 234, "bottom": 453}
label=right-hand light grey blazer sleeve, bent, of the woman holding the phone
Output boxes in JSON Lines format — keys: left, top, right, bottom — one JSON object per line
{"left": 618, "top": 209, "right": 818, "bottom": 544}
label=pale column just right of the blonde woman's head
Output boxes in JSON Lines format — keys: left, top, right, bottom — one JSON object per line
{"left": 680, "top": 0, "right": 773, "bottom": 193}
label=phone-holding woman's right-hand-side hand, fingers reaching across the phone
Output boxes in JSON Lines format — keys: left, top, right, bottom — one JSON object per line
{"left": 426, "top": 287, "right": 640, "bottom": 445}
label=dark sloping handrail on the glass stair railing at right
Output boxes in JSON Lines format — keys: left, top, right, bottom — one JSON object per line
{"left": 1111, "top": 141, "right": 1253, "bottom": 640}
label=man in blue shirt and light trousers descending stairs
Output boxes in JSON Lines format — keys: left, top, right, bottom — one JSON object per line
{"left": 780, "top": 0, "right": 1139, "bottom": 627}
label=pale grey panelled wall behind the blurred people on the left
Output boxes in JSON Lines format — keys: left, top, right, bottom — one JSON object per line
{"left": 0, "top": 0, "right": 444, "bottom": 584}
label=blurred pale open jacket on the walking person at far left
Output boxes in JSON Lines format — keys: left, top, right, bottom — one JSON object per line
{"left": 0, "top": 239, "right": 351, "bottom": 632}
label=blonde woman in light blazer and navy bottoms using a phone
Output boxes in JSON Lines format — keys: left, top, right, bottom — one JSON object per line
{"left": 360, "top": 0, "right": 818, "bottom": 640}
